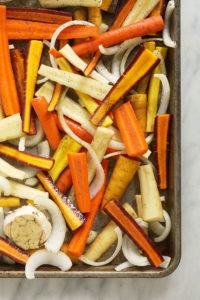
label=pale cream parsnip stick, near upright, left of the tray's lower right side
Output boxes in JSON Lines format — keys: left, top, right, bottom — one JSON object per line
{"left": 138, "top": 164, "right": 163, "bottom": 222}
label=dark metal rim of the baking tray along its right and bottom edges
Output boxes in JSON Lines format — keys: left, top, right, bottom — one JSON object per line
{"left": 0, "top": 0, "right": 181, "bottom": 278}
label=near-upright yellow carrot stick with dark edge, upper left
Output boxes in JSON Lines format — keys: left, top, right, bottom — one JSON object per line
{"left": 23, "top": 40, "right": 43, "bottom": 133}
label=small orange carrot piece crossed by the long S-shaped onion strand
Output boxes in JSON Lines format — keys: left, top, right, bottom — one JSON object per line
{"left": 54, "top": 114, "right": 93, "bottom": 143}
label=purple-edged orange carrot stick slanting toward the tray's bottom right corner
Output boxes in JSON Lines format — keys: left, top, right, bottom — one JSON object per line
{"left": 104, "top": 200, "right": 164, "bottom": 268}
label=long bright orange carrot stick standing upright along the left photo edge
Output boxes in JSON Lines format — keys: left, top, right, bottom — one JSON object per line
{"left": 0, "top": 6, "right": 20, "bottom": 116}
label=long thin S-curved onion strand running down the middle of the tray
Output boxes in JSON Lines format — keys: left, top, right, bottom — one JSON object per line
{"left": 57, "top": 105, "right": 105, "bottom": 198}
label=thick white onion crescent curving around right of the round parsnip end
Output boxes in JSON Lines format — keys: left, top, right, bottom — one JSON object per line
{"left": 34, "top": 197, "right": 67, "bottom": 253}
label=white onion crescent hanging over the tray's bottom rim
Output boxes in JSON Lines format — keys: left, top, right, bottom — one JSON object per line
{"left": 25, "top": 249, "right": 72, "bottom": 279}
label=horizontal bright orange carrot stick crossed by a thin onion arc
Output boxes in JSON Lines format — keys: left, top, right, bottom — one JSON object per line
{"left": 6, "top": 19, "right": 98, "bottom": 40}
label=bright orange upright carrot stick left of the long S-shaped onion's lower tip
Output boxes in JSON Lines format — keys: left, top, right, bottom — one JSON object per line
{"left": 68, "top": 152, "right": 91, "bottom": 213}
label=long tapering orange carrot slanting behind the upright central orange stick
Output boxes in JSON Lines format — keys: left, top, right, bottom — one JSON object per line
{"left": 67, "top": 160, "right": 109, "bottom": 257}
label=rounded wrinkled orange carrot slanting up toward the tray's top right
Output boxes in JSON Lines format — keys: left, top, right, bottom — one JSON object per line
{"left": 73, "top": 16, "right": 164, "bottom": 55}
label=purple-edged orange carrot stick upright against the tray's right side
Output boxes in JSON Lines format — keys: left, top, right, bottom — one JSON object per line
{"left": 155, "top": 114, "right": 171, "bottom": 189}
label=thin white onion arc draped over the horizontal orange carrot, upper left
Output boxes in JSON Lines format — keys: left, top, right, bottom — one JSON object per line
{"left": 50, "top": 20, "right": 94, "bottom": 68}
